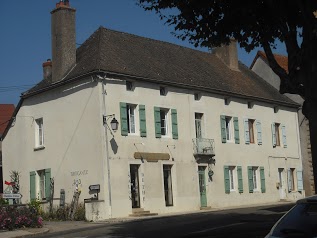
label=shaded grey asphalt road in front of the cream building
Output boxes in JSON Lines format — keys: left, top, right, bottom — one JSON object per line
{"left": 37, "top": 204, "right": 293, "bottom": 238}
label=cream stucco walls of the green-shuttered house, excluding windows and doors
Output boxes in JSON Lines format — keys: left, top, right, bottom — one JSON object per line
{"left": 3, "top": 73, "right": 305, "bottom": 220}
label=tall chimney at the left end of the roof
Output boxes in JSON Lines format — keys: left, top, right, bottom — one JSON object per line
{"left": 51, "top": 0, "right": 76, "bottom": 82}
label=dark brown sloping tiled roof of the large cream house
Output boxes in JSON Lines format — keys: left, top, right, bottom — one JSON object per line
{"left": 23, "top": 27, "right": 298, "bottom": 106}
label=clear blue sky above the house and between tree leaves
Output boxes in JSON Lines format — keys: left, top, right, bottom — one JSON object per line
{"left": 0, "top": 0, "right": 285, "bottom": 105}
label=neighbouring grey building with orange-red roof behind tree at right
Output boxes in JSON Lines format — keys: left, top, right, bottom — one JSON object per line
{"left": 250, "top": 51, "right": 315, "bottom": 196}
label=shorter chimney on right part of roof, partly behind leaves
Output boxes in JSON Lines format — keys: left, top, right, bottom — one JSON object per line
{"left": 213, "top": 39, "right": 239, "bottom": 71}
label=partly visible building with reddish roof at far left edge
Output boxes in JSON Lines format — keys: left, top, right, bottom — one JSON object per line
{"left": 0, "top": 104, "right": 14, "bottom": 193}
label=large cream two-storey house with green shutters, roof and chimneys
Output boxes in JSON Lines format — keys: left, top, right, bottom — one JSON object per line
{"left": 3, "top": 1, "right": 305, "bottom": 220}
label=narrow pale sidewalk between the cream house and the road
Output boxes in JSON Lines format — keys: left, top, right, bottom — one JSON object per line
{"left": 0, "top": 202, "right": 292, "bottom": 238}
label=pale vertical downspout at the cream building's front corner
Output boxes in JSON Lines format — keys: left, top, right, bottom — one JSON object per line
{"left": 98, "top": 75, "right": 112, "bottom": 218}
